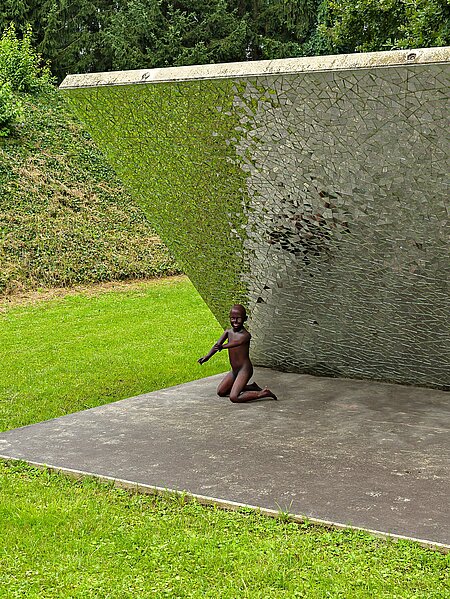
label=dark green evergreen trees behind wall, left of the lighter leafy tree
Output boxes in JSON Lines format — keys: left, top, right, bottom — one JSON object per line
{"left": 0, "top": 0, "right": 328, "bottom": 79}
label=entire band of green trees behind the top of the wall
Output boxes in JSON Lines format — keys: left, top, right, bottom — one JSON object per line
{"left": 0, "top": 0, "right": 450, "bottom": 79}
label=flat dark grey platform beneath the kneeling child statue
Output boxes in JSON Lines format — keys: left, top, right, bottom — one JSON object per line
{"left": 0, "top": 368, "right": 450, "bottom": 545}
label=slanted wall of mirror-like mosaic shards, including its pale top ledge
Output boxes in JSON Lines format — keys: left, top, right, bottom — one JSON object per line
{"left": 61, "top": 48, "right": 450, "bottom": 387}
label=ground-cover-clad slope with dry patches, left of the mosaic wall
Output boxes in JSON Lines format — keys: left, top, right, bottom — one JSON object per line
{"left": 0, "top": 91, "right": 176, "bottom": 293}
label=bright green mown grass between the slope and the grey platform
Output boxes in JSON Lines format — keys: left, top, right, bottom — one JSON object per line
{"left": 0, "top": 277, "right": 228, "bottom": 430}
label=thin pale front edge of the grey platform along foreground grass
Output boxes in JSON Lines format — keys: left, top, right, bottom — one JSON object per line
{"left": 0, "top": 455, "right": 450, "bottom": 554}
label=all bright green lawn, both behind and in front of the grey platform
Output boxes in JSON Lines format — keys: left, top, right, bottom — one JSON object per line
{"left": 0, "top": 279, "right": 450, "bottom": 599}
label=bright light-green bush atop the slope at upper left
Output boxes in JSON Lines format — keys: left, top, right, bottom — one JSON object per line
{"left": 0, "top": 23, "right": 52, "bottom": 93}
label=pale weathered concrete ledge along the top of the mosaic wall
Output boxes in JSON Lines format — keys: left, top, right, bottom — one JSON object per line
{"left": 60, "top": 46, "right": 450, "bottom": 89}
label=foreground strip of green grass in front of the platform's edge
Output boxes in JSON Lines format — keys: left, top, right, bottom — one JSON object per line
{"left": 0, "top": 463, "right": 449, "bottom": 599}
